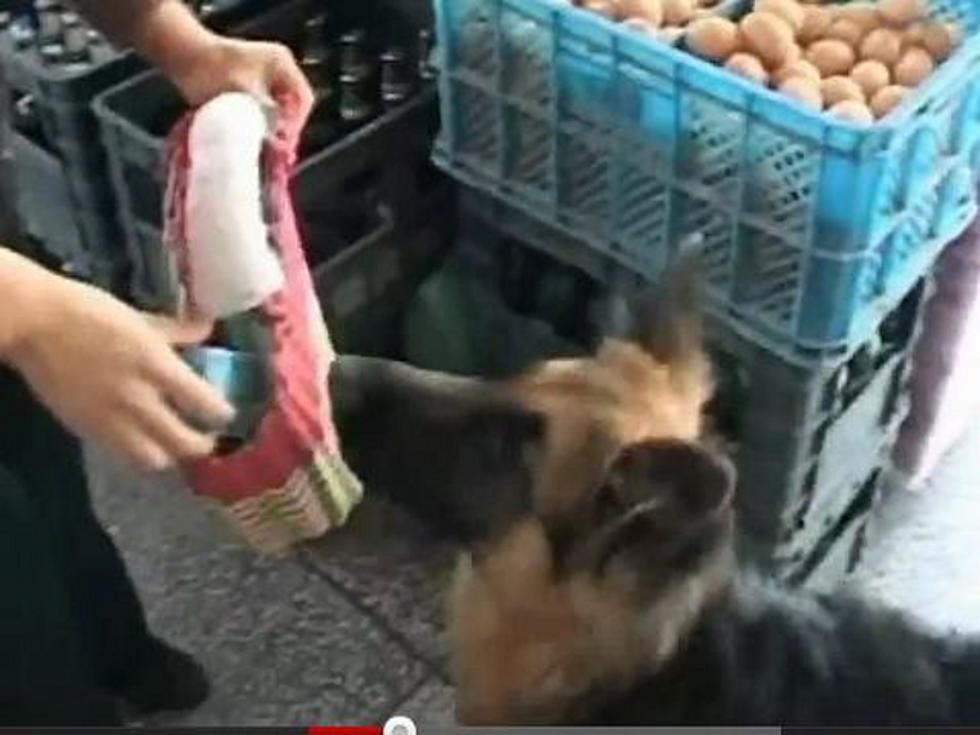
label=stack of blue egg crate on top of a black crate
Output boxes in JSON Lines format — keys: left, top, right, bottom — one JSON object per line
{"left": 422, "top": 0, "right": 980, "bottom": 581}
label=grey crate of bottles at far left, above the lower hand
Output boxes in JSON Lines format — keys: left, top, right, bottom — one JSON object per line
{"left": 0, "top": 2, "right": 138, "bottom": 288}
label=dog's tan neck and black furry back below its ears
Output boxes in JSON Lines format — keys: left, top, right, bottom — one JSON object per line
{"left": 453, "top": 548, "right": 980, "bottom": 726}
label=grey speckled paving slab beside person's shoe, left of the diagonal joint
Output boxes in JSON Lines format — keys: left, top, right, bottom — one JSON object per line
{"left": 90, "top": 448, "right": 427, "bottom": 725}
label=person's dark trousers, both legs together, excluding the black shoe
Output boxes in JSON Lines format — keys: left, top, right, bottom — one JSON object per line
{"left": 0, "top": 367, "right": 155, "bottom": 725}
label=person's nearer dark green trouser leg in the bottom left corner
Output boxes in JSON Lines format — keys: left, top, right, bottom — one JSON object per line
{"left": 0, "top": 462, "right": 120, "bottom": 727}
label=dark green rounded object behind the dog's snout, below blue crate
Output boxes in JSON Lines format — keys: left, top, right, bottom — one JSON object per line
{"left": 404, "top": 258, "right": 582, "bottom": 377}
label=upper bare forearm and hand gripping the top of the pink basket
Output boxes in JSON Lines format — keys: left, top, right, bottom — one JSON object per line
{"left": 76, "top": 0, "right": 313, "bottom": 121}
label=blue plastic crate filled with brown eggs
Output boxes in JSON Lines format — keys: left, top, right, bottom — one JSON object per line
{"left": 434, "top": 0, "right": 980, "bottom": 352}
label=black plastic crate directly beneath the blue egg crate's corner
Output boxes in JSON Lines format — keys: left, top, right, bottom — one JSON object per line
{"left": 710, "top": 285, "right": 925, "bottom": 570}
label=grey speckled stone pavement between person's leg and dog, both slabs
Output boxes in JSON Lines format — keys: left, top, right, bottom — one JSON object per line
{"left": 82, "top": 446, "right": 453, "bottom": 725}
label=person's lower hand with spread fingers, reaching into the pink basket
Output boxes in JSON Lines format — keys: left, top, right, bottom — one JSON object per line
{"left": 6, "top": 277, "right": 233, "bottom": 470}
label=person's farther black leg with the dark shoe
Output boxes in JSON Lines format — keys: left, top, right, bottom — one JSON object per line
{"left": 0, "top": 372, "right": 207, "bottom": 709}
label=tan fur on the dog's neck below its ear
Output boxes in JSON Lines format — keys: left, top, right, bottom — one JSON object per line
{"left": 450, "top": 522, "right": 734, "bottom": 725}
